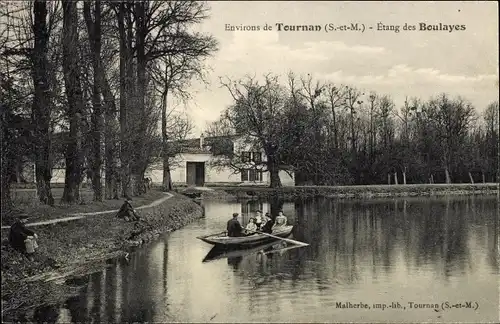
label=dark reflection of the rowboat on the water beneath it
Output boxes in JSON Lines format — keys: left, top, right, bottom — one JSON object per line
{"left": 202, "top": 241, "right": 303, "bottom": 269}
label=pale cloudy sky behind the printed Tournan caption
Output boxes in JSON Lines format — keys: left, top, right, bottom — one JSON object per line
{"left": 185, "top": 1, "right": 499, "bottom": 136}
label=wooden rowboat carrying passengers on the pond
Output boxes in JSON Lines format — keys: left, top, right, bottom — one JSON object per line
{"left": 197, "top": 225, "right": 293, "bottom": 247}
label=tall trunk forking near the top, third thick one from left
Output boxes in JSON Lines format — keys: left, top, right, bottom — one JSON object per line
{"left": 83, "top": 0, "right": 104, "bottom": 201}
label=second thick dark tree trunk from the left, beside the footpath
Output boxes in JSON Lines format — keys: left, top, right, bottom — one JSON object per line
{"left": 61, "top": 0, "right": 83, "bottom": 203}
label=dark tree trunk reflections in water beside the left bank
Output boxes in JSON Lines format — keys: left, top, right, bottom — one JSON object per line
{"left": 54, "top": 241, "right": 172, "bottom": 322}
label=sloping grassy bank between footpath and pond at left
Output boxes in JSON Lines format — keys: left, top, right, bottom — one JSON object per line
{"left": 1, "top": 193, "right": 202, "bottom": 321}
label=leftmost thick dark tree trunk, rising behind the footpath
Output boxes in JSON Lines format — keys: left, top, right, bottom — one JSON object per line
{"left": 31, "top": 0, "right": 54, "bottom": 206}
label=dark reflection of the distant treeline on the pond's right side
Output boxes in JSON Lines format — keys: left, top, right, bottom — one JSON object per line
{"left": 294, "top": 198, "right": 498, "bottom": 278}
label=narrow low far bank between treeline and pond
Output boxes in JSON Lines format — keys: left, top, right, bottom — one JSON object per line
{"left": 202, "top": 183, "right": 497, "bottom": 199}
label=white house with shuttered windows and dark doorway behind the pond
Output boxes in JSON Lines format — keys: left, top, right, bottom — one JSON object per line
{"left": 147, "top": 134, "right": 295, "bottom": 186}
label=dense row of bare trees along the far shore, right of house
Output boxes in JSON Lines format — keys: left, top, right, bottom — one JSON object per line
{"left": 208, "top": 74, "right": 499, "bottom": 187}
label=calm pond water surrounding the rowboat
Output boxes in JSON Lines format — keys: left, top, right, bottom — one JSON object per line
{"left": 44, "top": 197, "right": 499, "bottom": 323}
